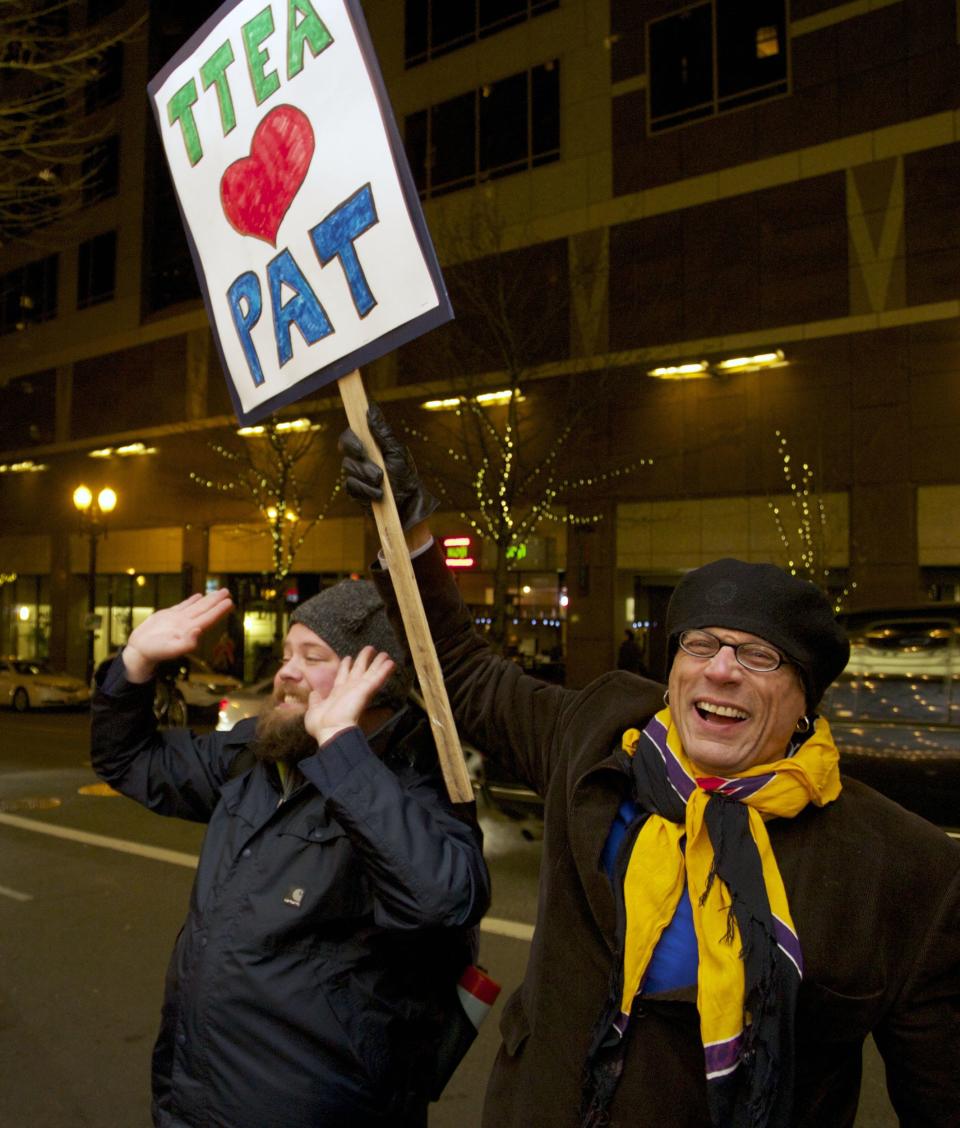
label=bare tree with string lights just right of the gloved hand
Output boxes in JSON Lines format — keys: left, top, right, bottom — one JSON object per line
{"left": 400, "top": 194, "right": 649, "bottom": 647}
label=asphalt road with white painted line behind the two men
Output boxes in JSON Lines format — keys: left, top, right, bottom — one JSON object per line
{"left": 0, "top": 712, "right": 897, "bottom": 1128}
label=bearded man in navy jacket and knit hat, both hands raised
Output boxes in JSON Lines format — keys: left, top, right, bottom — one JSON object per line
{"left": 93, "top": 580, "right": 490, "bottom": 1128}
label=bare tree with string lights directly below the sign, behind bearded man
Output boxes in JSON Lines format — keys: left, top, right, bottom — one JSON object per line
{"left": 190, "top": 415, "right": 341, "bottom": 641}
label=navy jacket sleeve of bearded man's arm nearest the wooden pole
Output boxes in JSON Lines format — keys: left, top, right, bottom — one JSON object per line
{"left": 299, "top": 729, "right": 490, "bottom": 928}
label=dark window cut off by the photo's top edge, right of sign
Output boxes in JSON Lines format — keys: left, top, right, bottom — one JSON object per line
{"left": 404, "top": 0, "right": 560, "bottom": 67}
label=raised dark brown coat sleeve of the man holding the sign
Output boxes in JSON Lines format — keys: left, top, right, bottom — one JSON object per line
{"left": 372, "top": 545, "right": 578, "bottom": 795}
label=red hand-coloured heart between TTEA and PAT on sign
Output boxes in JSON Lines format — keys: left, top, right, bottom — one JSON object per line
{"left": 220, "top": 106, "right": 315, "bottom": 247}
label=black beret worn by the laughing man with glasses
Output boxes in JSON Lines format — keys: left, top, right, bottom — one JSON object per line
{"left": 667, "top": 557, "right": 849, "bottom": 711}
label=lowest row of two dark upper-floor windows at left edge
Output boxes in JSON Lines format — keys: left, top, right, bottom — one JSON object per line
{"left": 0, "top": 231, "right": 116, "bottom": 335}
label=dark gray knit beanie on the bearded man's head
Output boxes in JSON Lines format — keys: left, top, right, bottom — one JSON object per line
{"left": 290, "top": 580, "right": 412, "bottom": 708}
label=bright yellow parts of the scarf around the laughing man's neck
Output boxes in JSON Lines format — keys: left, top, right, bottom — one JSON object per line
{"left": 620, "top": 708, "right": 840, "bottom": 1081}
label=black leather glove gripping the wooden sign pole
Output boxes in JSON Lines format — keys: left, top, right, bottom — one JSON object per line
{"left": 337, "top": 404, "right": 440, "bottom": 531}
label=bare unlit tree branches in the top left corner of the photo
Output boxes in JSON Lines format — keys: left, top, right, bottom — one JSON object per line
{"left": 0, "top": 0, "right": 147, "bottom": 244}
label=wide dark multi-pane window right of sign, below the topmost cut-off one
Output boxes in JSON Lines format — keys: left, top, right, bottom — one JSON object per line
{"left": 406, "top": 60, "right": 560, "bottom": 199}
